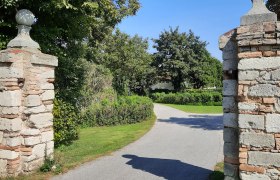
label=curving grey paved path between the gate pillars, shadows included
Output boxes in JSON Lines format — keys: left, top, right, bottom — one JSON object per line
{"left": 53, "top": 104, "right": 223, "bottom": 180}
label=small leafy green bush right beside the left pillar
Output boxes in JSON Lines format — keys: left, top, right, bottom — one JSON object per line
{"left": 53, "top": 100, "right": 78, "bottom": 147}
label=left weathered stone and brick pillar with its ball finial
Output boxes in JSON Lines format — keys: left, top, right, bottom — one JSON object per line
{"left": 0, "top": 10, "right": 58, "bottom": 177}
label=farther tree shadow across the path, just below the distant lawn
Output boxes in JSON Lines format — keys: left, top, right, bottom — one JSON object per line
{"left": 158, "top": 115, "right": 224, "bottom": 130}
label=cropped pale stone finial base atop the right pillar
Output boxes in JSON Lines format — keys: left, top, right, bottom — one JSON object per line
{"left": 241, "top": 0, "right": 277, "bottom": 25}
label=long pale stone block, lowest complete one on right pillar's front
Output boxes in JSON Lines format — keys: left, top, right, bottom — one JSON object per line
{"left": 248, "top": 151, "right": 280, "bottom": 167}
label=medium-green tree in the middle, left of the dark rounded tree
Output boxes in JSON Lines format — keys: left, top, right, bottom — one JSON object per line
{"left": 95, "top": 29, "right": 154, "bottom": 95}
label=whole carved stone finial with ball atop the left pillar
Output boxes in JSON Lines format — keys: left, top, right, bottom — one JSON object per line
{"left": 8, "top": 9, "right": 40, "bottom": 49}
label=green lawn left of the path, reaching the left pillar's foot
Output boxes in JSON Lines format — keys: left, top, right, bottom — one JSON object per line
{"left": 7, "top": 116, "right": 156, "bottom": 180}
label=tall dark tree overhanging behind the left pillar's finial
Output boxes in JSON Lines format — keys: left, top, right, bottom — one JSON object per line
{"left": 0, "top": 0, "right": 140, "bottom": 101}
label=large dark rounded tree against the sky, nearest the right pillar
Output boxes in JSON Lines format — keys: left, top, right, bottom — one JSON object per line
{"left": 153, "top": 27, "right": 222, "bottom": 92}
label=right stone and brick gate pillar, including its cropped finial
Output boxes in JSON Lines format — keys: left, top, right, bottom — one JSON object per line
{"left": 220, "top": 0, "right": 280, "bottom": 180}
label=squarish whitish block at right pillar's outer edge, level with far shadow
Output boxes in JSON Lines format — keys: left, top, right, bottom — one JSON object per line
{"left": 265, "top": 114, "right": 280, "bottom": 133}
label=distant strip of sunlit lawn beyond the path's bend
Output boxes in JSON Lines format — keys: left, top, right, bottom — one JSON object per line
{"left": 164, "top": 104, "right": 223, "bottom": 114}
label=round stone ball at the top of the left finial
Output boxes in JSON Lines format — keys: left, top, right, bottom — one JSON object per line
{"left": 16, "top": 9, "right": 36, "bottom": 26}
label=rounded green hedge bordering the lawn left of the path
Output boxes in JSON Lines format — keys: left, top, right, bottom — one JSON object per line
{"left": 80, "top": 96, "right": 153, "bottom": 127}
